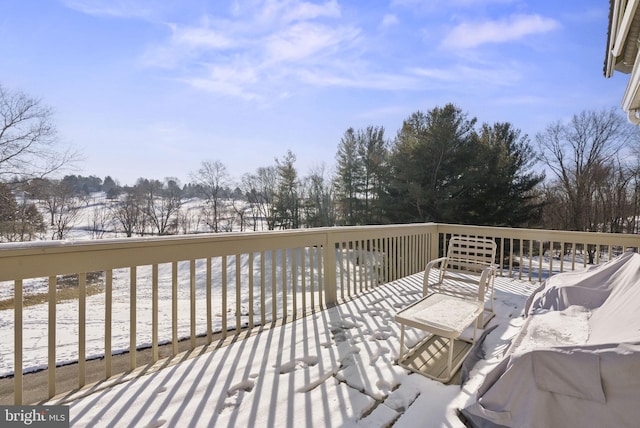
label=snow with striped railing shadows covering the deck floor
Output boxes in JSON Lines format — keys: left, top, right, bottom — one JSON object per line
{"left": 55, "top": 274, "right": 537, "bottom": 428}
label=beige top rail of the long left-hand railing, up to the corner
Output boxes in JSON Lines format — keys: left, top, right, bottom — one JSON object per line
{"left": 0, "top": 224, "right": 435, "bottom": 281}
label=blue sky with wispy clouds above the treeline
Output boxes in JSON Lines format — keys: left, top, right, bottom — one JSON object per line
{"left": 0, "top": 0, "right": 628, "bottom": 184}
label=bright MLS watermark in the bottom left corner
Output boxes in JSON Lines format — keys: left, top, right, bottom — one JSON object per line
{"left": 0, "top": 406, "right": 69, "bottom": 428}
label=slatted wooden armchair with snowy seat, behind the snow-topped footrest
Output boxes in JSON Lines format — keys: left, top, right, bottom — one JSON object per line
{"left": 422, "top": 236, "right": 497, "bottom": 327}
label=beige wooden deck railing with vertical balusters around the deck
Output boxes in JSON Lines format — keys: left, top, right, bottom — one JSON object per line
{"left": 0, "top": 223, "right": 640, "bottom": 404}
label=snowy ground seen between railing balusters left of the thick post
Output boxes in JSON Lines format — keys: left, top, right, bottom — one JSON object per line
{"left": 0, "top": 250, "right": 320, "bottom": 376}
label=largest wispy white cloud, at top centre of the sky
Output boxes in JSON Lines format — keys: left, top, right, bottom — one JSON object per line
{"left": 143, "top": 0, "right": 368, "bottom": 99}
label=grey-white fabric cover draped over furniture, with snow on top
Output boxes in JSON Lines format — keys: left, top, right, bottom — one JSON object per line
{"left": 462, "top": 252, "right": 640, "bottom": 427}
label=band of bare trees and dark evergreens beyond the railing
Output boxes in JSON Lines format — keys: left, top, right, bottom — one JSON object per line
{"left": 0, "top": 100, "right": 640, "bottom": 241}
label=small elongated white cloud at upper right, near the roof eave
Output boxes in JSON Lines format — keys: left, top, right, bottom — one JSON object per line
{"left": 441, "top": 14, "right": 560, "bottom": 49}
